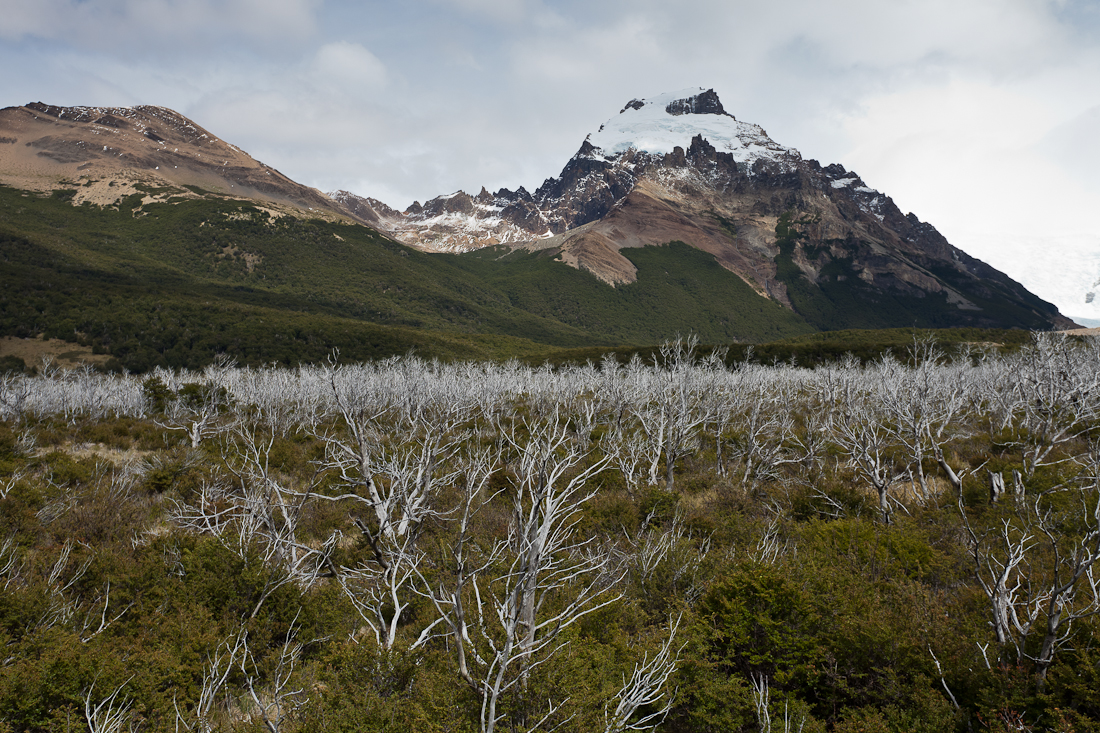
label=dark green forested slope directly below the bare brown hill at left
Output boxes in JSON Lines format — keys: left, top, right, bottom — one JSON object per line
{"left": 0, "top": 179, "right": 606, "bottom": 371}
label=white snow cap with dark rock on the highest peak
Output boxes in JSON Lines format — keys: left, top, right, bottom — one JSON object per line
{"left": 587, "top": 87, "right": 801, "bottom": 164}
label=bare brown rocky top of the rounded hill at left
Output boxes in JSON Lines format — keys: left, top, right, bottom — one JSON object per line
{"left": 0, "top": 102, "right": 349, "bottom": 217}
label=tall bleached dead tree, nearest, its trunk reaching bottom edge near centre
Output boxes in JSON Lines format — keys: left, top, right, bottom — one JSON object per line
{"left": 418, "top": 416, "right": 618, "bottom": 733}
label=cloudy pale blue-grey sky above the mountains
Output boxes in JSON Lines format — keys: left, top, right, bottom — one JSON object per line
{"left": 0, "top": 0, "right": 1100, "bottom": 322}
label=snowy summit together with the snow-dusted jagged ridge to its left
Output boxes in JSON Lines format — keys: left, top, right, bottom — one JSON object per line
{"left": 330, "top": 87, "right": 802, "bottom": 251}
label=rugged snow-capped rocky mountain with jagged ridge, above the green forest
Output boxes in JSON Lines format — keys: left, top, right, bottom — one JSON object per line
{"left": 343, "top": 88, "right": 1073, "bottom": 329}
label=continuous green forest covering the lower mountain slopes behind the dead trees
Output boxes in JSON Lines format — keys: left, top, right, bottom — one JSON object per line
{"left": 0, "top": 186, "right": 1064, "bottom": 372}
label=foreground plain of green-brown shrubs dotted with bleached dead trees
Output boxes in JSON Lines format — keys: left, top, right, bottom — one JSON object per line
{"left": 0, "top": 333, "right": 1100, "bottom": 733}
